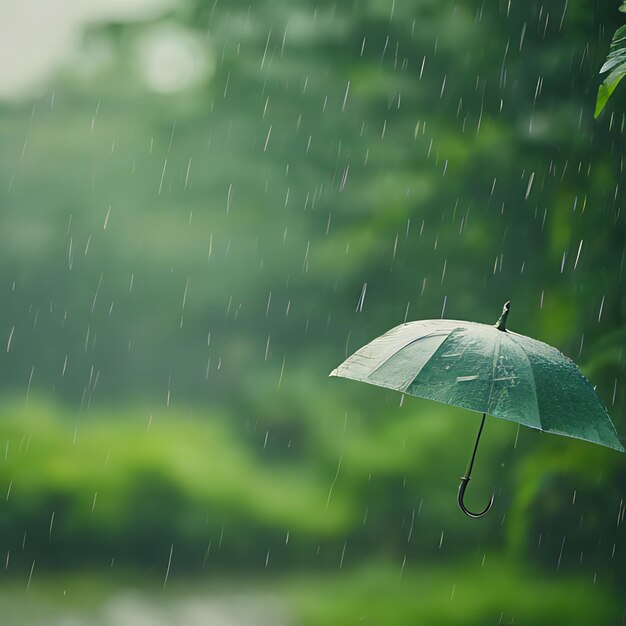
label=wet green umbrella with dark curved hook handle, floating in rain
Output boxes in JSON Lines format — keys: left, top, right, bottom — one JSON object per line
{"left": 330, "top": 302, "right": 624, "bottom": 517}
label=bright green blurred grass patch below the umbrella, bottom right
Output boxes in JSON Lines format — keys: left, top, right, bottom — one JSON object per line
{"left": 282, "top": 558, "right": 620, "bottom": 626}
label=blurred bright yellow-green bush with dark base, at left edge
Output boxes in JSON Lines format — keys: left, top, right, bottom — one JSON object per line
{"left": 0, "top": 402, "right": 350, "bottom": 567}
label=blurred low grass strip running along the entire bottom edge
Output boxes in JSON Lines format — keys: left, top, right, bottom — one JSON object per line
{"left": 0, "top": 555, "right": 623, "bottom": 626}
